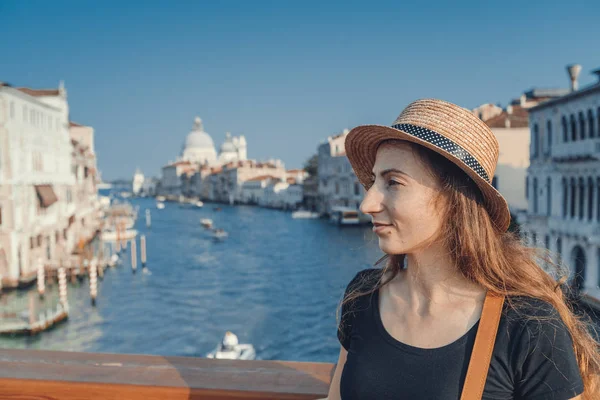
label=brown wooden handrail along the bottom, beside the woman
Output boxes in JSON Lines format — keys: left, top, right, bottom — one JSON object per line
{"left": 0, "top": 349, "right": 334, "bottom": 400}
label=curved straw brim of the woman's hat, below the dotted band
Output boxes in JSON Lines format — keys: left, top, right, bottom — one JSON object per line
{"left": 345, "top": 125, "right": 511, "bottom": 232}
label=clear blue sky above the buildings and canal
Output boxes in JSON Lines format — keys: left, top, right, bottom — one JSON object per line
{"left": 0, "top": 0, "right": 600, "bottom": 179}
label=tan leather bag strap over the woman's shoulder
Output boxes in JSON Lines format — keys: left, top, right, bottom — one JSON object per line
{"left": 460, "top": 291, "right": 504, "bottom": 400}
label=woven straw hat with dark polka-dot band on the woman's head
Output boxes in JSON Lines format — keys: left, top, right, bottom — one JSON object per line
{"left": 345, "top": 99, "right": 510, "bottom": 232}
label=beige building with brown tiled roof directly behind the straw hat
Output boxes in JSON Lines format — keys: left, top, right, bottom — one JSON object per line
{"left": 472, "top": 89, "right": 568, "bottom": 214}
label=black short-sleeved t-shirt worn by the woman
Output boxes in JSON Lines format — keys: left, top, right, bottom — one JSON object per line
{"left": 338, "top": 269, "right": 583, "bottom": 400}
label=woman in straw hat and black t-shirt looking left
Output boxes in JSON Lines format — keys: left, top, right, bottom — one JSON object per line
{"left": 328, "top": 100, "right": 600, "bottom": 400}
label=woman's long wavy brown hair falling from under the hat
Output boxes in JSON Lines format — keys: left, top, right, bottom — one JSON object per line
{"left": 337, "top": 140, "right": 600, "bottom": 399}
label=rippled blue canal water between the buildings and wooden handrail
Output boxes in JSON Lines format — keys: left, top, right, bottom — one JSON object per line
{"left": 0, "top": 199, "right": 381, "bottom": 362}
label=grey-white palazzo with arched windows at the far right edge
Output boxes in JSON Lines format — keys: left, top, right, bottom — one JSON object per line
{"left": 519, "top": 66, "right": 600, "bottom": 297}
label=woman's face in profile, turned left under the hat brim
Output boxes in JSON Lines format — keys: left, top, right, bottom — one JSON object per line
{"left": 360, "top": 141, "right": 444, "bottom": 254}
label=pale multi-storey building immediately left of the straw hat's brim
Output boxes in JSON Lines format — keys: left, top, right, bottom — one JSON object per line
{"left": 318, "top": 129, "right": 370, "bottom": 221}
